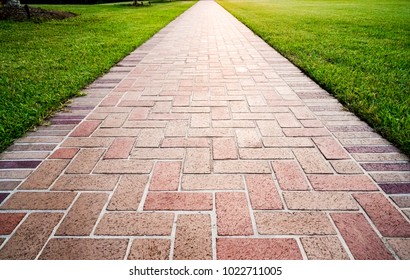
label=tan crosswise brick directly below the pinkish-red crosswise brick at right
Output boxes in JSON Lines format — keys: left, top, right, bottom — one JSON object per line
{"left": 283, "top": 191, "right": 359, "bottom": 210}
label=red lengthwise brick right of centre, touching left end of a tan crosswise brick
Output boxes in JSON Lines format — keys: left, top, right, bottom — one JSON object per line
{"left": 245, "top": 175, "right": 283, "bottom": 210}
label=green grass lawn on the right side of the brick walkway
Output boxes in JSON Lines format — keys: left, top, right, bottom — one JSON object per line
{"left": 218, "top": 0, "right": 410, "bottom": 155}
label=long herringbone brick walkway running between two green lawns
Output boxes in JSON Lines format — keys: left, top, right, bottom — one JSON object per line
{"left": 0, "top": 1, "right": 410, "bottom": 259}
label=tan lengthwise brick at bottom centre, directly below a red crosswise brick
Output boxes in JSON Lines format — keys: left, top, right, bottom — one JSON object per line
{"left": 173, "top": 214, "right": 212, "bottom": 260}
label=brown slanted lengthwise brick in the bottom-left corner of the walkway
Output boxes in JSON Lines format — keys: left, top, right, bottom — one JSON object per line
{"left": 0, "top": 213, "right": 63, "bottom": 260}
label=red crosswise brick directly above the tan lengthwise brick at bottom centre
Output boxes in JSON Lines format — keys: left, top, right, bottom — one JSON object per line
{"left": 144, "top": 192, "right": 213, "bottom": 211}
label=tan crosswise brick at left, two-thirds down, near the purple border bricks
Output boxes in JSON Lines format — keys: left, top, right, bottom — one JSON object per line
{"left": 52, "top": 174, "right": 119, "bottom": 191}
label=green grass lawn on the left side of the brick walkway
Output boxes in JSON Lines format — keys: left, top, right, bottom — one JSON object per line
{"left": 0, "top": 1, "right": 195, "bottom": 151}
